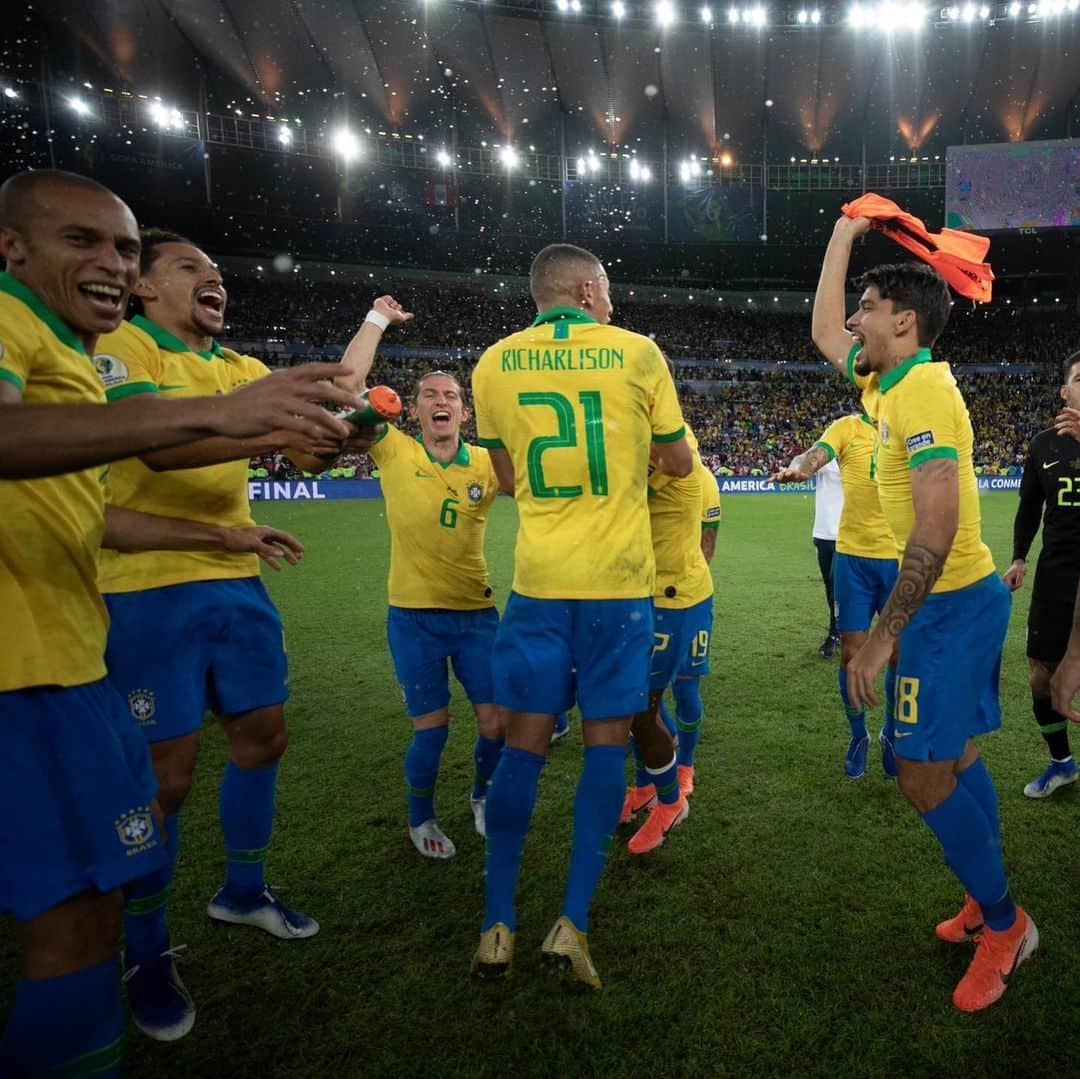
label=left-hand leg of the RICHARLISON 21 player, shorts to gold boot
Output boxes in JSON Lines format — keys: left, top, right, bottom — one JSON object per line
{"left": 472, "top": 592, "right": 574, "bottom": 979}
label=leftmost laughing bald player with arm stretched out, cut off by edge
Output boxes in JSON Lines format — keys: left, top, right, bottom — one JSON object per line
{"left": 0, "top": 170, "right": 358, "bottom": 1076}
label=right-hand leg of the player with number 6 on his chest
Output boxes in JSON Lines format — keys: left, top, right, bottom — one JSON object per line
{"left": 450, "top": 607, "right": 505, "bottom": 836}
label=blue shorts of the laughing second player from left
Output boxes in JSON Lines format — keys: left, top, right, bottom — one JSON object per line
{"left": 105, "top": 577, "right": 288, "bottom": 742}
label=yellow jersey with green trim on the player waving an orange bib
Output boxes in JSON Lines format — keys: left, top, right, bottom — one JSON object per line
{"left": 875, "top": 349, "right": 994, "bottom": 592}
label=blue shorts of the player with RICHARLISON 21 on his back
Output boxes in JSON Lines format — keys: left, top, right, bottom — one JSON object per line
{"left": 494, "top": 592, "right": 652, "bottom": 719}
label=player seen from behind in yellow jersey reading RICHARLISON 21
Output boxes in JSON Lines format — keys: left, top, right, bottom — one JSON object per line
{"left": 473, "top": 244, "right": 693, "bottom": 987}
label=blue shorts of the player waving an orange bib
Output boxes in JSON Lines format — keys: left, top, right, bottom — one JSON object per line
{"left": 893, "top": 574, "right": 1012, "bottom": 760}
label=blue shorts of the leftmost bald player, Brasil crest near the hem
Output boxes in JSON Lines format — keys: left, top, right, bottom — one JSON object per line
{"left": 0, "top": 678, "right": 165, "bottom": 921}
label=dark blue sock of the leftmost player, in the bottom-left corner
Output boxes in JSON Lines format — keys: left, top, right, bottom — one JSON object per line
{"left": 0, "top": 956, "right": 124, "bottom": 1079}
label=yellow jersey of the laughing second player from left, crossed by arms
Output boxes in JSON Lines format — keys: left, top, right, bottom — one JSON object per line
{"left": 94, "top": 315, "right": 269, "bottom": 592}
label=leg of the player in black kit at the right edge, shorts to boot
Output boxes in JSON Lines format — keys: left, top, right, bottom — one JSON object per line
{"left": 1024, "top": 578, "right": 1080, "bottom": 798}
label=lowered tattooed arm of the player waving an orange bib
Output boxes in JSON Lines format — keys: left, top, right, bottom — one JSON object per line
{"left": 848, "top": 457, "right": 960, "bottom": 707}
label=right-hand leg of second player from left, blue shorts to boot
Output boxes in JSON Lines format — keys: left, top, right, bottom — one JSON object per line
{"left": 203, "top": 578, "right": 319, "bottom": 940}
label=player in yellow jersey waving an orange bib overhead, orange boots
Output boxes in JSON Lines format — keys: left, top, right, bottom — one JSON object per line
{"left": 813, "top": 217, "right": 1039, "bottom": 1011}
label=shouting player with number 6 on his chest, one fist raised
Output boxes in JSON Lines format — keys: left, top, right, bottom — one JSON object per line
{"left": 328, "top": 296, "right": 503, "bottom": 859}
